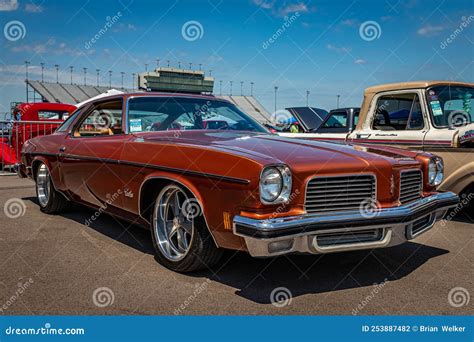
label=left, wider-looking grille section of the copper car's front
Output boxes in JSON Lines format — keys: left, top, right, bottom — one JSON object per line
{"left": 305, "top": 175, "right": 376, "bottom": 213}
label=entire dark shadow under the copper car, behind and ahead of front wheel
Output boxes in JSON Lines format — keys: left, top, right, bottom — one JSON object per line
{"left": 24, "top": 197, "right": 449, "bottom": 304}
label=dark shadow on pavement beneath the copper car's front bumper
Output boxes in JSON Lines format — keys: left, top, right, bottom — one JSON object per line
{"left": 194, "top": 242, "right": 449, "bottom": 304}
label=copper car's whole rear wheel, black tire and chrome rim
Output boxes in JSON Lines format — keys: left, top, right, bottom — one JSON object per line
{"left": 35, "top": 163, "right": 70, "bottom": 214}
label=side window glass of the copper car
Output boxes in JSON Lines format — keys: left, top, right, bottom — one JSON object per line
{"left": 74, "top": 101, "right": 123, "bottom": 137}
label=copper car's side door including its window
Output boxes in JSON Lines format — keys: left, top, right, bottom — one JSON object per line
{"left": 58, "top": 98, "right": 129, "bottom": 209}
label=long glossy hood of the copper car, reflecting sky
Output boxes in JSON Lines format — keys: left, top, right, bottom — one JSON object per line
{"left": 137, "top": 131, "right": 419, "bottom": 172}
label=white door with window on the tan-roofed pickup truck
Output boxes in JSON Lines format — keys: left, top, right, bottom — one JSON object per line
{"left": 352, "top": 90, "right": 429, "bottom": 149}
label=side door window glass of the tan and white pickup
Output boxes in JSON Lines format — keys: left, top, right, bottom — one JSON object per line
{"left": 372, "top": 94, "right": 424, "bottom": 131}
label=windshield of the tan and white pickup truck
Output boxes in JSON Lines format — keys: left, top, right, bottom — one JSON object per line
{"left": 427, "top": 86, "right": 474, "bottom": 128}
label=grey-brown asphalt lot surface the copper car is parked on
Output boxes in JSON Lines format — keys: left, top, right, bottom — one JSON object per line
{"left": 0, "top": 176, "right": 474, "bottom": 315}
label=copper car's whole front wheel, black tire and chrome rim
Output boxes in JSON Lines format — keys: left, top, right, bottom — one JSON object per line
{"left": 151, "top": 184, "right": 222, "bottom": 273}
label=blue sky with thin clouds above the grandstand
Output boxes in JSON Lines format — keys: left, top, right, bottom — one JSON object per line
{"left": 0, "top": 0, "right": 474, "bottom": 112}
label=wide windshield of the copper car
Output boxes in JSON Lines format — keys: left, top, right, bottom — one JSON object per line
{"left": 128, "top": 96, "right": 268, "bottom": 133}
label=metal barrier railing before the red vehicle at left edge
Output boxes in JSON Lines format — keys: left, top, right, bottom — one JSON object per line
{"left": 0, "top": 120, "right": 62, "bottom": 172}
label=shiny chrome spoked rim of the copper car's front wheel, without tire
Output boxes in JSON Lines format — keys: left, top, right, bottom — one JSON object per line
{"left": 153, "top": 185, "right": 194, "bottom": 261}
